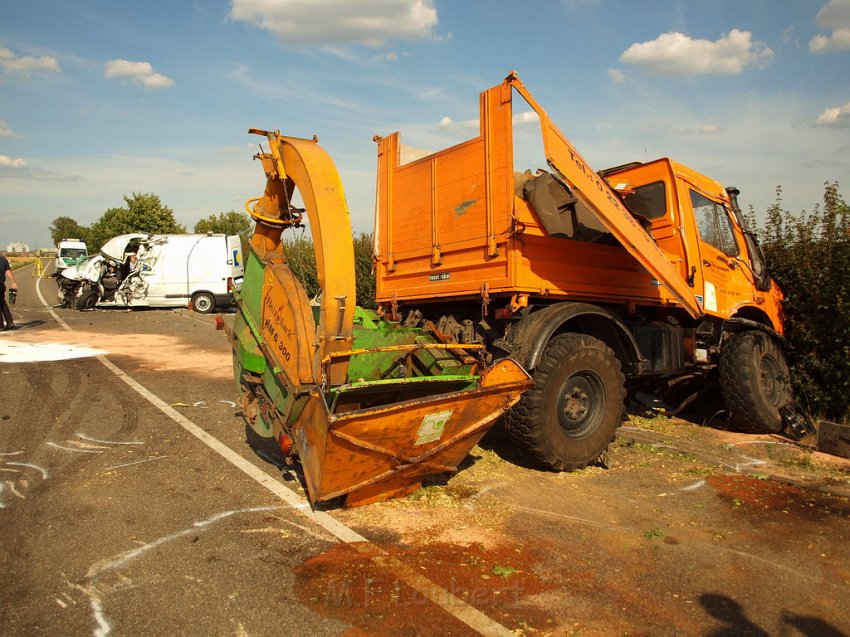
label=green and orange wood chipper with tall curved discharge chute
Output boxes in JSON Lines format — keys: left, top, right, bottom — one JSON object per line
{"left": 229, "top": 130, "right": 532, "bottom": 505}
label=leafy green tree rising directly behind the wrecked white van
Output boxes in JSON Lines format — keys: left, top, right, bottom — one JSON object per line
{"left": 89, "top": 192, "right": 186, "bottom": 252}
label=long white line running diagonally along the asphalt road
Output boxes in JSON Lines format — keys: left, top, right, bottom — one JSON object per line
{"left": 36, "top": 280, "right": 515, "bottom": 637}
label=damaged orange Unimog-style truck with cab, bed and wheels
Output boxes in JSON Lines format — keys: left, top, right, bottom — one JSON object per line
{"left": 375, "top": 73, "right": 803, "bottom": 470}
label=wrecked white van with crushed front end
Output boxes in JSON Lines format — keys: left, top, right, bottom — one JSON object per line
{"left": 57, "top": 233, "right": 245, "bottom": 313}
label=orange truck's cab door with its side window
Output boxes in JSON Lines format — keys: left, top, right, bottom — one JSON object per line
{"left": 689, "top": 189, "right": 753, "bottom": 318}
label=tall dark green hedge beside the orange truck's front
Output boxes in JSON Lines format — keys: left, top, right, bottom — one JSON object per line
{"left": 750, "top": 182, "right": 850, "bottom": 420}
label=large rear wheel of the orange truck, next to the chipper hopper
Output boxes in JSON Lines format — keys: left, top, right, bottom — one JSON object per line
{"left": 505, "top": 334, "right": 626, "bottom": 471}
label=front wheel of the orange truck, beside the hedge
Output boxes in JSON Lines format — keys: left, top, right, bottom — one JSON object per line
{"left": 719, "top": 331, "right": 792, "bottom": 433}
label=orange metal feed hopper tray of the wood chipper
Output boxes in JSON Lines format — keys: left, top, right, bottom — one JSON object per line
{"left": 293, "top": 359, "right": 531, "bottom": 506}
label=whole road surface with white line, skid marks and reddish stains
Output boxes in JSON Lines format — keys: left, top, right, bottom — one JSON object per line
{"left": 0, "top": 260, "right": 850, "bottom": 637}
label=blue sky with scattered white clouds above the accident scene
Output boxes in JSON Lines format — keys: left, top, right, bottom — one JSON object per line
{"left": 0, "top": 0, "right": 850, "bottom": 248}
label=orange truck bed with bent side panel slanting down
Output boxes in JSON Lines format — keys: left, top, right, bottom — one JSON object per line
{"left": 375, "top": 74, "right": 700, "bottom": 316}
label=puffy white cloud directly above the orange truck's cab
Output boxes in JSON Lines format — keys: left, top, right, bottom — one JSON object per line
{"left": 620, "top": 29, "right": 773, "bottom": 75}
